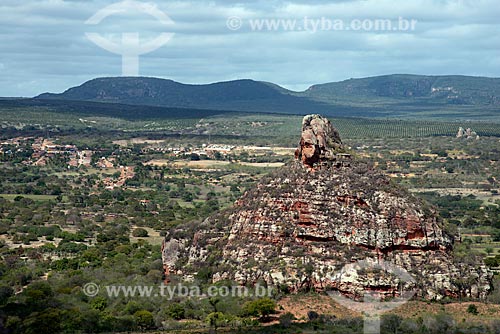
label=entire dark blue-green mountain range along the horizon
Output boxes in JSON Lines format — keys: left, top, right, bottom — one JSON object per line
{"left": 14, "top": 74, "right": 500, "bottom": 119}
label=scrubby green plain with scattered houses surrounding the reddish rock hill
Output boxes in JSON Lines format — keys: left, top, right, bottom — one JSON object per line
{"left": 0, "top": 109, "right": 500, "bottom": 333}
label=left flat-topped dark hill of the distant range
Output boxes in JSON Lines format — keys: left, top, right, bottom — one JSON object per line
{"left": 37, "top": 77, "right": 330, "bottom": 113}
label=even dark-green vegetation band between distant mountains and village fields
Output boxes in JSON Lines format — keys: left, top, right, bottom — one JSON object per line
{"left": 0, "top": 105, "right": 500, "bottom": 147}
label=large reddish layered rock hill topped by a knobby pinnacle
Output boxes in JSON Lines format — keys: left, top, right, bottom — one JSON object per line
{"left": 163, "top": 115, "right": 492, "bottom": 299}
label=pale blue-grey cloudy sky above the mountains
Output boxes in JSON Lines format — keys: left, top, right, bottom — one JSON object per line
{"left": 0, "top": 0, "right": 500, "bottom": 97}
